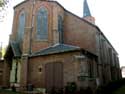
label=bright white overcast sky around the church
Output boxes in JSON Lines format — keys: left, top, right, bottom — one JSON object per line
{"left": 0, "top": 0, "right": 125, "bottom": 66}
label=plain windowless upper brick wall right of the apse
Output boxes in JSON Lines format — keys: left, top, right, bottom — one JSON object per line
{"left": 64, "top": 12, "right": 96, "bottom": 53}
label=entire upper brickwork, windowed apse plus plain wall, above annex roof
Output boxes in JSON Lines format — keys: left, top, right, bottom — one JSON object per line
{"left": 12, "top": 0, "right": 96, "bottom": 53}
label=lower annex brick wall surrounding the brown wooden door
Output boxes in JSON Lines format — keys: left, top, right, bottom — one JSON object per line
{"left": 28, "top": 52, "right": 80, "bottom": 87}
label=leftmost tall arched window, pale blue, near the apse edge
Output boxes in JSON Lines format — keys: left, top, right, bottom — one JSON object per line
{"left": 17, "top": 12, "right": 25, "bottom": 42}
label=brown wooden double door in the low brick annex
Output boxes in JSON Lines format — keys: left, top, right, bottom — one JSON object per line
{"left": 45, "top": 63, "right": 63, "bottom": 90}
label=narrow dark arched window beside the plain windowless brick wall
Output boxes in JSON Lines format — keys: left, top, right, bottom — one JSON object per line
{"left": 58, "top": 15, "right": 63, "bottom": 43}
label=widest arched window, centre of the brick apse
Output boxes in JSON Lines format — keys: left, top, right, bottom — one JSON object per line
{"left": 36, "top": 7, "right": 48, "bottom": 40}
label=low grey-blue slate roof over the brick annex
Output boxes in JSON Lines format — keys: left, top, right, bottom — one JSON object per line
{"left": 30, "top": 44, "right": 80, "bottom": 57}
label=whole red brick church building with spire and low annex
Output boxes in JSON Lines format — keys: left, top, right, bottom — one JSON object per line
{"left": 2, "top": 0, "right": 121, "bottom": 91}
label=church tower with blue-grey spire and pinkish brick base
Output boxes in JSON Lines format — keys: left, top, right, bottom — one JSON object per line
{"left": 83, "top": 0, "right": 95, "bottom": 24}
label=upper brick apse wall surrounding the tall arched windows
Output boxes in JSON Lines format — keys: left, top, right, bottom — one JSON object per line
{"left": 11, "top": 0, "right": 64, "bottom": 53}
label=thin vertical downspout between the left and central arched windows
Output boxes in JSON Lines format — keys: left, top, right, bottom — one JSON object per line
{"left": 29, "top": 0, "right": 36, "bottom": 55}
